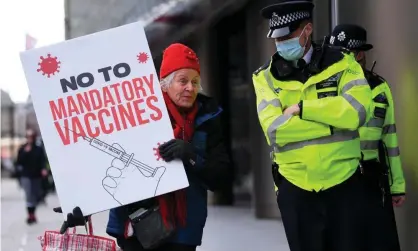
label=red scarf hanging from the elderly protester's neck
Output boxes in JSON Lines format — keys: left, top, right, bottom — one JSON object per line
{"left": 158, "top": 92, "right": 198, "bottom": 229}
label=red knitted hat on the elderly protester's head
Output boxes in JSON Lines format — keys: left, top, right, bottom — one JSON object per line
{"left": 160, "top": 43, "right": 200, "bottom": 79}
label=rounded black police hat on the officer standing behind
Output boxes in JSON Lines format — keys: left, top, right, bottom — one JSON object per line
{"left": 329, "top": 24, "right": 373, "bottom": 51}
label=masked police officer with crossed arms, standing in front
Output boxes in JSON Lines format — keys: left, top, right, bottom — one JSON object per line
{"left": 253, "top": 0, "right": 371, "bottom": 251}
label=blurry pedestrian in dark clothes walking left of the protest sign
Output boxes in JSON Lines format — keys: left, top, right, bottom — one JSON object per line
{"left": 16, "top": 129, "right": 47, "bottom": 224}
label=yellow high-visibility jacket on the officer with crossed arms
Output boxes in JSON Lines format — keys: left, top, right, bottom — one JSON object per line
{"left": 253, "top": 48, "right": 371, "bottom": 191}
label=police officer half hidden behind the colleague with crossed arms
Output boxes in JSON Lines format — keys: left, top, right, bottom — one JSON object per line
{"left": 329, "top": 24, "right": 405, "bottom": 251}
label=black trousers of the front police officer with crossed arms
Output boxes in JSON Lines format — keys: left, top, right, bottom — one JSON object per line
{"left": 277, "top": 172, "right": 365, "bottom": 251}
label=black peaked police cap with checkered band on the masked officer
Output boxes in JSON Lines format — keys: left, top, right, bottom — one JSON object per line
{"left": 261, "top": 0, "right": 314, "bottom": 38}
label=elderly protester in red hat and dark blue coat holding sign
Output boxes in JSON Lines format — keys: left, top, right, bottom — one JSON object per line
{"left": 54, "top": 43, "right": 229, "bottom": 251}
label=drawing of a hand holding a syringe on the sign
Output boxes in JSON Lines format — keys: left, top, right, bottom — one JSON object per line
{"left": 66, "top": 128, "right": 165, "bottom": 205}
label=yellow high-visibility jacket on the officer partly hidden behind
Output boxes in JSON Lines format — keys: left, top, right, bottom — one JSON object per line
{"left": 359, "top": 71, "right": 405, "bottom": 195}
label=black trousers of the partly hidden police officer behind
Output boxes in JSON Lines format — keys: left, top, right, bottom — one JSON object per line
{"left": 364, "top": 163, "right": 401, "bottom": 251}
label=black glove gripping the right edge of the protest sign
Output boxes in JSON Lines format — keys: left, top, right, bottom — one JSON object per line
{"left": 158, "top": 139, "right": 197, "bottom": 166}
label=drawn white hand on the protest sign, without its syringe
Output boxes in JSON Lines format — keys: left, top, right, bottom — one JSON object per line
{"left": 102, "top": 144, "right": 165, "bottom": 205}
